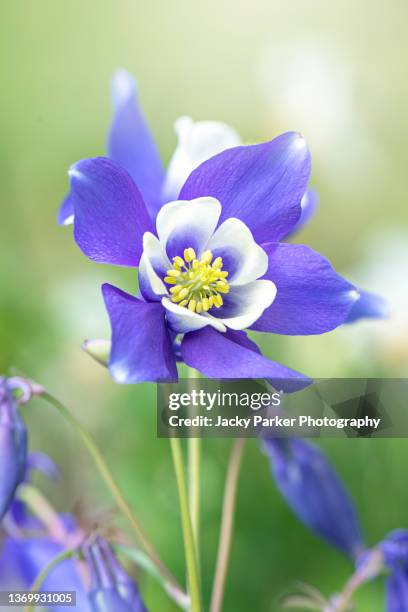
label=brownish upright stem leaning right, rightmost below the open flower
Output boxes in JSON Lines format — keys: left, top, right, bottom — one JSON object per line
{"left": 210, "top": 438, "right": 246, "bottom": 612}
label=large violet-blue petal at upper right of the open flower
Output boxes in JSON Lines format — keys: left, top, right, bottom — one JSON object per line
{"left": 180, "top": 132, "right": 310, "bottom": 244}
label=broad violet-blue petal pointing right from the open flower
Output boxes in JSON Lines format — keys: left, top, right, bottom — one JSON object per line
{"left": 252, "top": 243, "right": 358, "bottom": 335}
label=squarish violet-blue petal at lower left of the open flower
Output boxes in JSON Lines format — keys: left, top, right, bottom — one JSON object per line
{"left": 102, "top": 284, "right": 177, "bottom": 383}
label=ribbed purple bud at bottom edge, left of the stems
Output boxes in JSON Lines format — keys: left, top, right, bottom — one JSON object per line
{"left": 83, "top": 537, "right": 146, "bottom": 612}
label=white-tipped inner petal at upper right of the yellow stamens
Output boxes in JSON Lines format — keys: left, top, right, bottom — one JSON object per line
{"left": 207, "top": 217, "right": 268, "bottom": 286}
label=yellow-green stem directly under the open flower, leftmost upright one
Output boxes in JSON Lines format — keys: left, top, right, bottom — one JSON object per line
{"left": 170, "top": 437, "right": 202, "bottom": 612}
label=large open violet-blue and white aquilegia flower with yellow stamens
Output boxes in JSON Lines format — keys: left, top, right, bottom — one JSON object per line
{"left": 60, "top": 69, "right": 384, "bottom": 383}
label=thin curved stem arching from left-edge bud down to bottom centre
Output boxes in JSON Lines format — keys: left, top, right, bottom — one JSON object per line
{"left": 41, "top": 391, "right": 183, "bottom": 591}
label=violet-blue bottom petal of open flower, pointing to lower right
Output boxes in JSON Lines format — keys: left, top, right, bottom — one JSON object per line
{"left": 181, "top": 327, "right": 309, "bottom": 391}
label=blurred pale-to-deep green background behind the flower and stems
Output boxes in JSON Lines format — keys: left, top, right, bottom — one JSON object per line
{"left": 0, "top": 0, "right": 408, "bottom": 612}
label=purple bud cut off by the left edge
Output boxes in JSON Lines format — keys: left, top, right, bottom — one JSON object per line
{"left": 0, "top": 378, "right": 27, "bottom": 520}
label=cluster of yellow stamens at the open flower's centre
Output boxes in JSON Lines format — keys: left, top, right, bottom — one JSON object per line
{"left": 164, "top": 247, "right": 230, "bottom": 313}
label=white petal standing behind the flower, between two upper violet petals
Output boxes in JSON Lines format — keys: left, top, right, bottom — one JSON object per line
{"left": 163, "top": 117, "right": 241, "bottom": 202}
